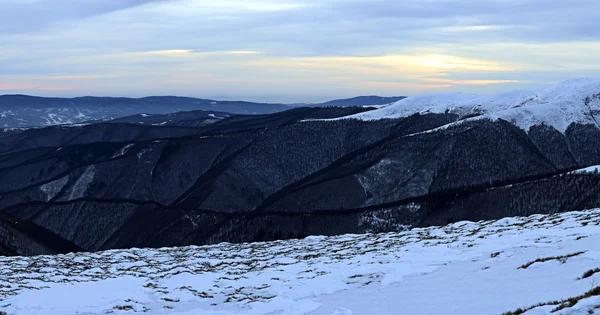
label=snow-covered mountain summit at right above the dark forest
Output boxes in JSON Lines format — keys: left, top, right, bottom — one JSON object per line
{"left": 336, "top": 79, "right": 600, "bottom": 133}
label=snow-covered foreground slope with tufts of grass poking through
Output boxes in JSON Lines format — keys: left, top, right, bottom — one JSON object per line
{"left": 0, "top": 209, "right": 600, "bottom": 315}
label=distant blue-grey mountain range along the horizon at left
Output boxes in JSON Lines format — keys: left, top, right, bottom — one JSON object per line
{"left": 0, "top": 95, "right": 400, "bottom": 128}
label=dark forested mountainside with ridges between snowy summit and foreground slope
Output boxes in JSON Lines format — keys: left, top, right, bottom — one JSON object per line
{"left": 0, "top": 102, "right": 600, "bottom": 255}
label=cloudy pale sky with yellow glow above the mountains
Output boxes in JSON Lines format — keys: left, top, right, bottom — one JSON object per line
{"left": 0, "top": 0, "right": 600, "bottom": 103}
